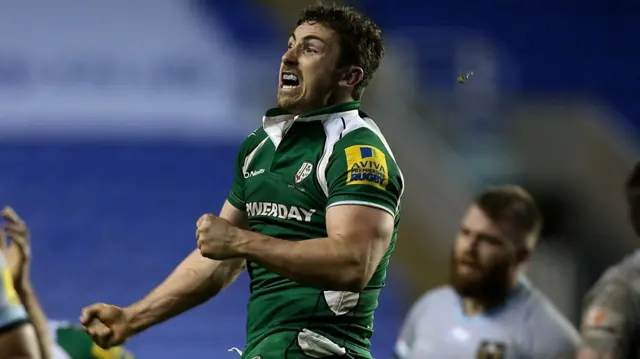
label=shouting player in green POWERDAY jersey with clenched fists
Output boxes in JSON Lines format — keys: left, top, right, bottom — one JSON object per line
{"left": 81, "top": 6, "right": 403, "bottom": 359}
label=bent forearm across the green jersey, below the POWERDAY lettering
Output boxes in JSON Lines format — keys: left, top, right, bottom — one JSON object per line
{"left": 239, "top": 231, "right": 371, "bottom": 292}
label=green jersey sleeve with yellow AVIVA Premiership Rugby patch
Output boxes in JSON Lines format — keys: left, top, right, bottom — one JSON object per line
{"left": 327, "top": 128, "right": 403, "bottom": 216}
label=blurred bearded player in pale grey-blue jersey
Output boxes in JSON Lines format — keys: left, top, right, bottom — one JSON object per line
{"left": 395, "top": 186, "right": 579, "bottom": 359}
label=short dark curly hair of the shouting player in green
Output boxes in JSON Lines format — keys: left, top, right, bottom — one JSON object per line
{"left": 297, "top": 5, "right": 384, "bottom": 100}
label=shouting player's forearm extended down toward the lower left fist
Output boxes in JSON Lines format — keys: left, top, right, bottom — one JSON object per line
{"left": 125, "top": 251, "right": 244, "bottom": 334}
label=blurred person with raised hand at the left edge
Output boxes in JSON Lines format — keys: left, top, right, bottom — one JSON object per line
{"left": 0, "top": 207, "right": 51, "bottom": 359}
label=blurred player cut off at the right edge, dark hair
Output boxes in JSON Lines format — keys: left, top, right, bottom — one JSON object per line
{"left": 578, "top": 162, "right": 640, "bottom": 359}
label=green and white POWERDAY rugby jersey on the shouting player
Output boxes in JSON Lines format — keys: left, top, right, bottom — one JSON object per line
{"left": 228, "top": 102, "right": 403, "bottom": 357}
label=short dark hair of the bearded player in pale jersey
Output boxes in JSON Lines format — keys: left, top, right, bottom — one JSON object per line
{"left": 473, "top": 185, "right": 542, "bottom": 245}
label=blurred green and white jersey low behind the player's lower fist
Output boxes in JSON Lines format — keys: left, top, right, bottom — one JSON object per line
{"left": 48, "top": 320, "right": 134, "bottom": 359}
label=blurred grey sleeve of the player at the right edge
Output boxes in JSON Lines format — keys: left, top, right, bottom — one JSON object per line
{"left": 579, "top": 281, "right": 637, "bottom": 359}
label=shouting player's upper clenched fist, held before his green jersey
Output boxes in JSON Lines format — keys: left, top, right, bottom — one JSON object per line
{"left": 196, "top": 214, "right": 243, "bottom": 260}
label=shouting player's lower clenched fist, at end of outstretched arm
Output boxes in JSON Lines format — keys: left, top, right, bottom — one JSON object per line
{"left": 80, "top": 303, "right": 134, "bottom": 349}
